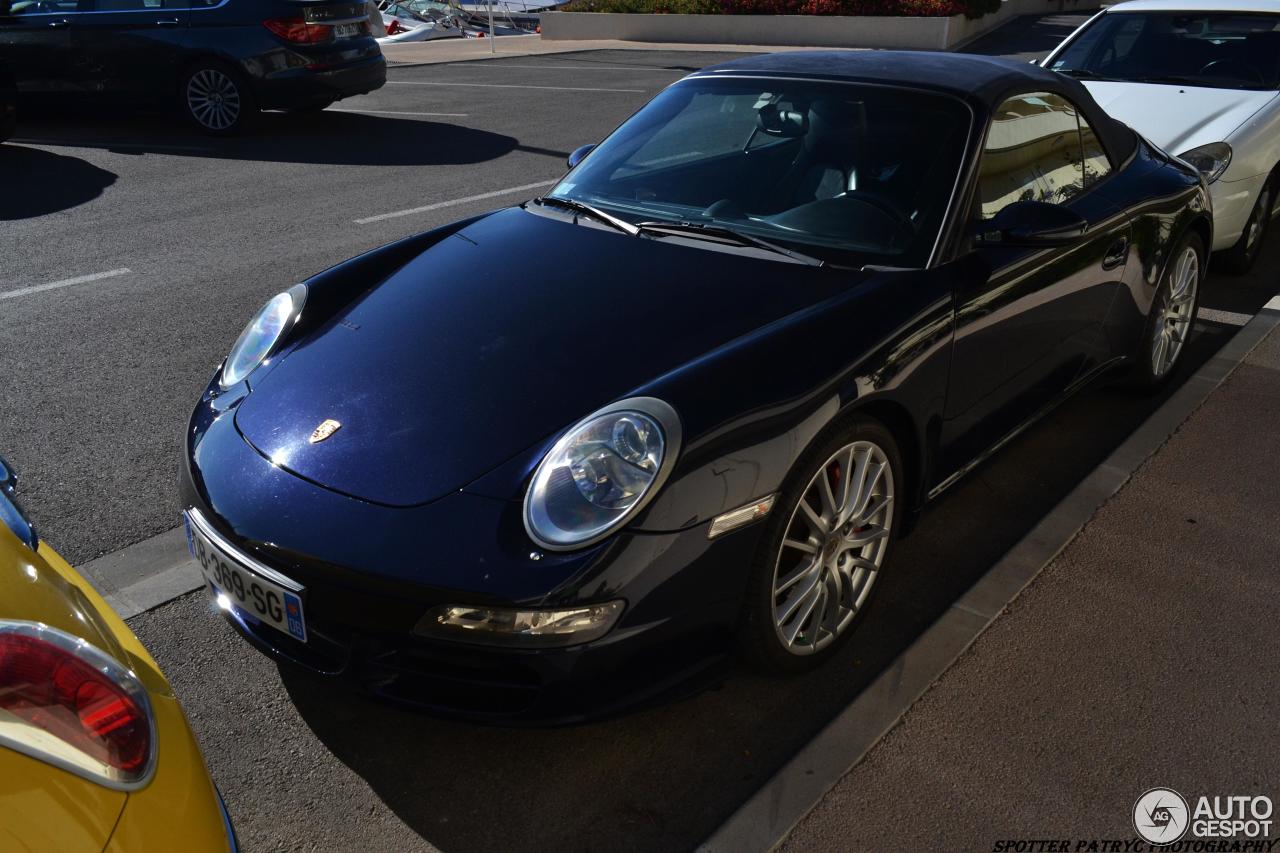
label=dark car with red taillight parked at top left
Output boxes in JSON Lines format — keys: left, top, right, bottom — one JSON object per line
{"left": 0, "top": 0, "right": 387, "bottom": 134}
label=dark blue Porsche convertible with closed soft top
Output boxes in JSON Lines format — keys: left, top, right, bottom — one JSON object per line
{"left": 183, "top": 51, "right": 1212, "bottom": 720}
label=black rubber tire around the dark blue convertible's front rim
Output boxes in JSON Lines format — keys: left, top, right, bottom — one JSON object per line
{"left": 739, "top": 415, "right": 906, "bottom": 674}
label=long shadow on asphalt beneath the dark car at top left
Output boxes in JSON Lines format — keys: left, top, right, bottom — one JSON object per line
{"left": 14, "top": 109, "right": 568, "bottom": 167}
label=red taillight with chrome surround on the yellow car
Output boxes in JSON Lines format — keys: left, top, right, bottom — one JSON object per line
{"left": 0, "top": 620, "right": 155, "bottom": 790}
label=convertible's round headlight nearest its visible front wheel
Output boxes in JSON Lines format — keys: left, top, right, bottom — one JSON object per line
{"left": 525, "top": 397, "right": 680, "bottom": 551}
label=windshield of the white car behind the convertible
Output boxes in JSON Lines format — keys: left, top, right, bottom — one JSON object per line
{"left": 1050, "top": 12, "right": 1280, "bottom": 90}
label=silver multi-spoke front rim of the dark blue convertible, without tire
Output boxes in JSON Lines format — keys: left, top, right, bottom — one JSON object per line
{"left": 773, "top": 441, "right": 895, "bottom": 656}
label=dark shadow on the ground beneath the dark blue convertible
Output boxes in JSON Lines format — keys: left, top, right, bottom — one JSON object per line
{"left": 272, "top": 235, "right": 1280, "bottom": 853}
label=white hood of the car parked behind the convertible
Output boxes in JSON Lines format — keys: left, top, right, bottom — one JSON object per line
{"left": 1084, "top": 81, "right": 1276, "bottom": 155}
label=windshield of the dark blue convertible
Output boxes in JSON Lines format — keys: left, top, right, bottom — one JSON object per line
{"left": 549, "top": 78, "right": 970, "bottom": 266}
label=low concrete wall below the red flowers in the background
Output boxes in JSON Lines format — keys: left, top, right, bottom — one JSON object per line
{"left": 541, "top": 0, "right": 1096, "bottom": 50}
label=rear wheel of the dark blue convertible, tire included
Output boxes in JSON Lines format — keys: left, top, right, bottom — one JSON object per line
{"left": 1134, "top": 233, "right": 1204, "bottom": 391}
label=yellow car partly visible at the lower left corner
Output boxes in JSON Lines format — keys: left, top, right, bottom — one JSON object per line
{"left": 0, "top": 459, "right": 236, "bottom": 853}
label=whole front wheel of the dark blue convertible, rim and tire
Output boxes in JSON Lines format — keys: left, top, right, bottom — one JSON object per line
{"left": 742, "top": 418, "right": 902, "bottom": 671}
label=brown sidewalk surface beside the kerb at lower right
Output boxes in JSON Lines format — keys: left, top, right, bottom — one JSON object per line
{"left": 783, "top": 320, "right": 1280, "bottom": 850}
